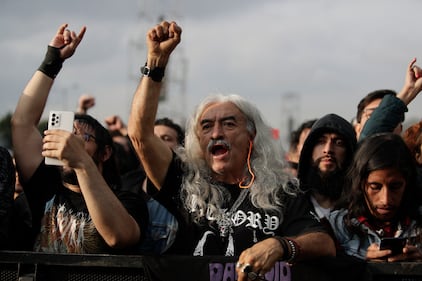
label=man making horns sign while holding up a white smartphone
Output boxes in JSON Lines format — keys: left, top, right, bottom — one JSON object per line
{"left": 12, "top": 24, "right": 146, "bottom": 253}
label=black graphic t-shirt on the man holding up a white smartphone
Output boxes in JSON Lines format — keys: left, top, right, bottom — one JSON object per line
{"left": 23, "top": 162, "right": 148, "bottom": 253}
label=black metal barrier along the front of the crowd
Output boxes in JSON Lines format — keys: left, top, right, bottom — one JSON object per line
{"left": 0, "top": 251, "right": 422, "bottom": 281}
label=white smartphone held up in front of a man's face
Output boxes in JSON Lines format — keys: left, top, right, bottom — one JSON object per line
{"left": 45, "top": 110, "right": 75, "bottom": 166}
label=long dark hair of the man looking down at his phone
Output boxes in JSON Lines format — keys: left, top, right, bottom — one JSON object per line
{"left": 342, "top": 133, "right": 420, "bottom": 234}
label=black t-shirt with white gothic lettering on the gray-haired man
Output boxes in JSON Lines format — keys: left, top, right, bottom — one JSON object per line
{"left": 154, "top": 154, "right": 326, "bottom": 256}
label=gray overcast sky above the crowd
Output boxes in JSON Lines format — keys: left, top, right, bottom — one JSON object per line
{"left": 0, "top": 0, "right": 422, "bottom": 144}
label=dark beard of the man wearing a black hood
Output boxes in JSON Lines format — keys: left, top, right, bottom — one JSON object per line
{"left": 306, "top": 163, "right": 344, "bottom": 201}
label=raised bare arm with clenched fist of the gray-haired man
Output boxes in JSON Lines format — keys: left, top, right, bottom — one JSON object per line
{"left": 128, "top": 21, "right": 182, "bottom": 188}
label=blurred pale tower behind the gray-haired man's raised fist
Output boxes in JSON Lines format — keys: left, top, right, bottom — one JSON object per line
{"left": 128, "top": 0, "right": 188, "bottom": 126}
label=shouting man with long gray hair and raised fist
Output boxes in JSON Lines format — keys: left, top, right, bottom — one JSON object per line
{"left": 128, "top": 21, "right": 335, "bottom": 280}
